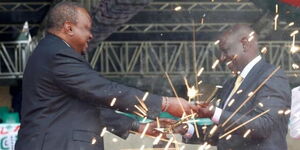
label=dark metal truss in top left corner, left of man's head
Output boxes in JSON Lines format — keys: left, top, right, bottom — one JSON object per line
{"left": 0, "top": 2, "right": 51, "bottom": 12}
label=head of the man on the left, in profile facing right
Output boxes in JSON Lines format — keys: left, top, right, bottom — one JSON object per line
{"left": 47, "top": 2, "right": 93, "bottom": 53}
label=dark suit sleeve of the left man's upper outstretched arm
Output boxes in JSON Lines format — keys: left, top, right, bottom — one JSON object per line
{"left": 51, "top": 50, "right": 162, "bottom": 119}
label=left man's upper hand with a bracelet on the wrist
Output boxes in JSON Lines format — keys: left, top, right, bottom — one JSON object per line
{"left": 162, "top": 97, "right": 198, "bottom": 117}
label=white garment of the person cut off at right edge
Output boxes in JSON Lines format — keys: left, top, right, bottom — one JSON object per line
{"left": 289, "top": 86, "right": 300, "bottom": 139}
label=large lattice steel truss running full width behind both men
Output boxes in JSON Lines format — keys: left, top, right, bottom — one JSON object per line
{"left": 0, "top": 41, "right": 300, "bottom": 79}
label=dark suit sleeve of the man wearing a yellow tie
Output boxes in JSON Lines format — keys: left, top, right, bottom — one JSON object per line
{"left": 220, "top": 73, "right": 291, "bottom": 138}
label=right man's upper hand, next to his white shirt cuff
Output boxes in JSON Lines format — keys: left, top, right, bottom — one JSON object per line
{"left": 197, "top": 103, "right": 215, "bottom": 118}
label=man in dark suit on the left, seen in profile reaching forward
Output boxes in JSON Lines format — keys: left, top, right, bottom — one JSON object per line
{"left": 16, "top": 2, "right": 195, "bottom": 150}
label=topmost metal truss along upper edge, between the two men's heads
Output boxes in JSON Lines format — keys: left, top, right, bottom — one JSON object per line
{"left": 143, "top": 0, "right": 261, "bottom": 12}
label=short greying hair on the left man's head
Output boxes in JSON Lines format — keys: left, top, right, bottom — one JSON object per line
{"left": 46, "top": 2, "right": 84, "bottom": 30}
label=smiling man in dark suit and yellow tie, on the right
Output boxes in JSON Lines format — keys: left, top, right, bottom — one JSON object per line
{"left": 186, "top": 25, "right": 291, "bottom": 150}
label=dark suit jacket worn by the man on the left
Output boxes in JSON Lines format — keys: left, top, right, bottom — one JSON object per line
{"left": 16, "top": 34, "right": 161, "bottom": 150}
